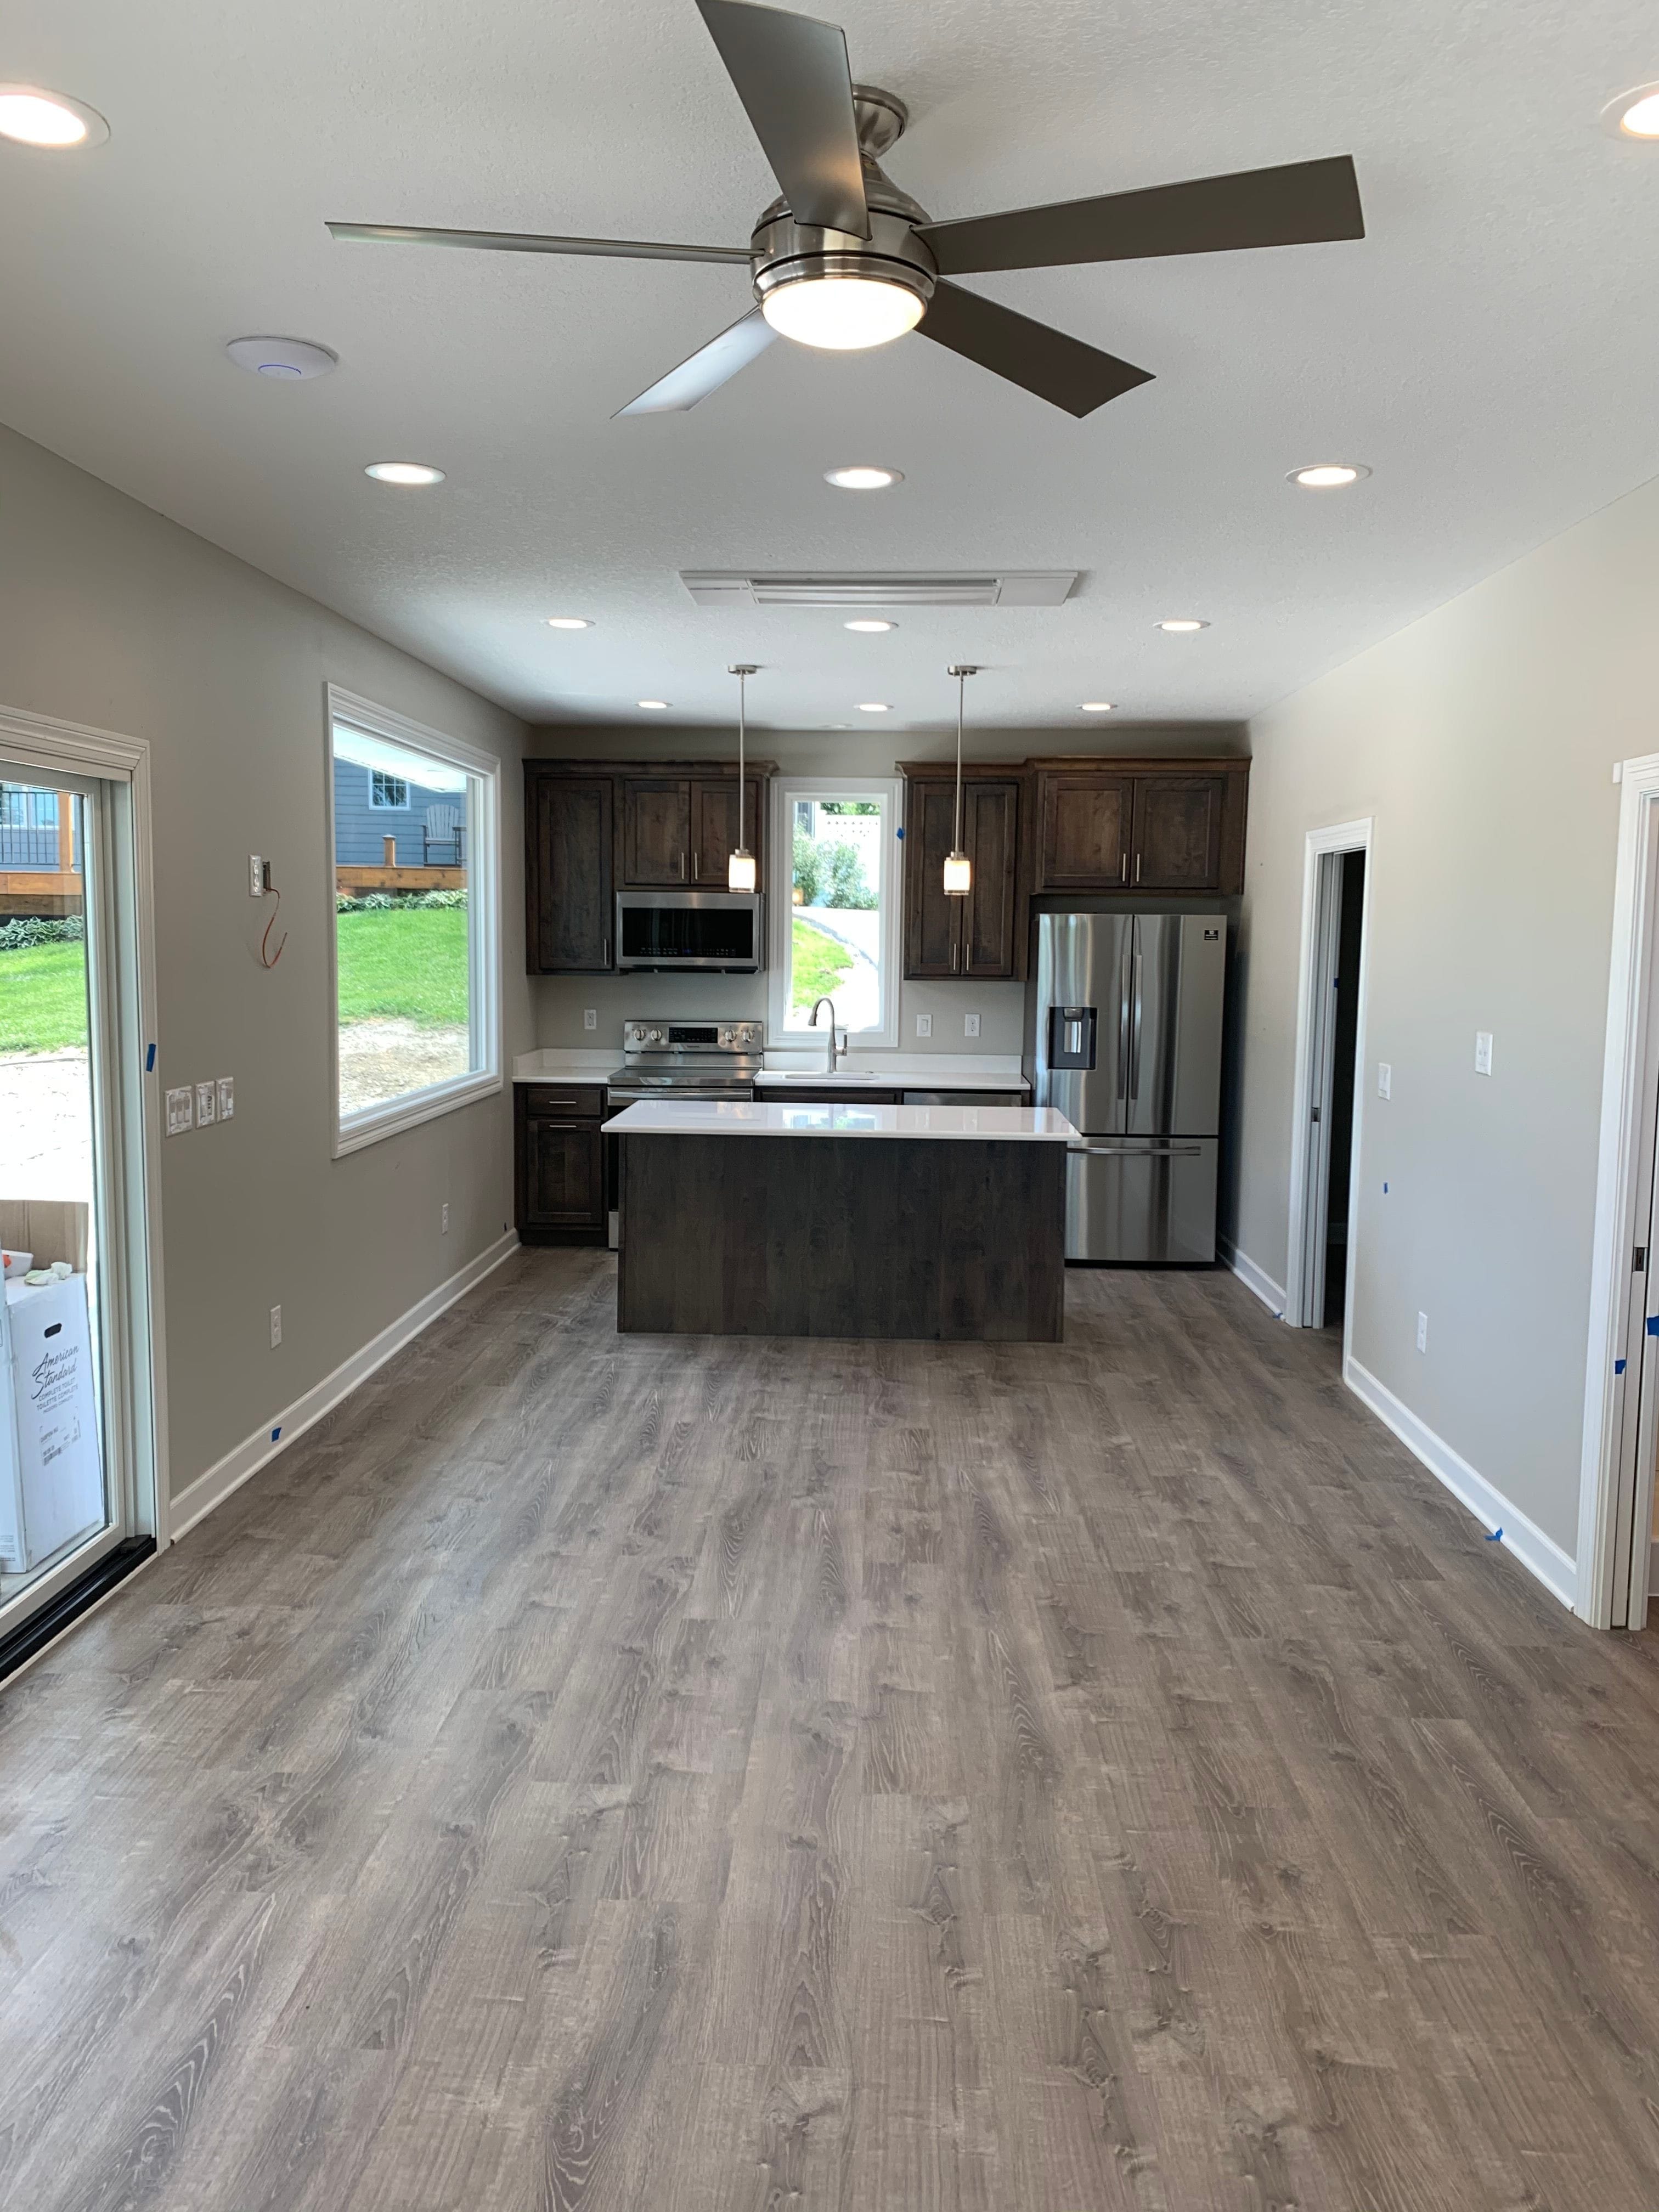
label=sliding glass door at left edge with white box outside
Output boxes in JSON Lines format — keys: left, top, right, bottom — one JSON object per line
{"left": 0, "top": 712, "right": 161, "bottom": 1674}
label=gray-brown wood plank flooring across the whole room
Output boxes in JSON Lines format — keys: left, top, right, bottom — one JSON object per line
{"left": 0, "top": 1252, "right": 1659, "bottom": 2212}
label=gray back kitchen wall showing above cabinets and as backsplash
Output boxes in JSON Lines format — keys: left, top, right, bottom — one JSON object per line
{"left": 529, "top": 712, "right": 1248, "bottom": 1055}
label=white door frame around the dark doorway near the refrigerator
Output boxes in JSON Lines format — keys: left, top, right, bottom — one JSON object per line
{"left": 1285, "top": 814, "right": 1374, "bottom": 1374}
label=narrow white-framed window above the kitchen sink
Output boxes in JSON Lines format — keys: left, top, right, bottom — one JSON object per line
{"left": 770, "top": 776, "right": 898, "bottom": 1046}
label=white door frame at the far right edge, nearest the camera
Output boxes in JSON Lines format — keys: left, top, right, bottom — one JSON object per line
{"left": 1573, "top": 752, "right": 1659, "bottom": 1628}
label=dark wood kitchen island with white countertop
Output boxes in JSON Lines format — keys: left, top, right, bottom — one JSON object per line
{"left": 606, "top": 1099, "right": 1077, "bottom": 1342}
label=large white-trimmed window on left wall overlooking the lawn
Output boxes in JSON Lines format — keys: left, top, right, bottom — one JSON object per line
{"left": 330, "top": 686, "right": 502, "bottom": 1157}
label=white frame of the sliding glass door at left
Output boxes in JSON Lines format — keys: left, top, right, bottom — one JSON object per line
{"left": 0, "top": 706, "right": 170, "bottom": 1566}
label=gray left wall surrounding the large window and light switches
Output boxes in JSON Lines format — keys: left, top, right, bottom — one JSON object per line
{"left": 0, "top": 429, "right": 531, "bottom": 1493}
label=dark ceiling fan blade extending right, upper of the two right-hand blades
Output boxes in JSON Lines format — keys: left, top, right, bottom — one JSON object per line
{"left": 918, "top": 153, "right": 1365, "bottom": 276}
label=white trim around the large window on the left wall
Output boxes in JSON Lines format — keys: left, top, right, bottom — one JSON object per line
{"left": 323, "top": 684, "right": 502, "bottom": 1159}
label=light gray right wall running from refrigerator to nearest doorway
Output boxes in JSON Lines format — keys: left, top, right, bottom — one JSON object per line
{"left": 1232, "top": 466, "right": 1659, "bottom": 1555}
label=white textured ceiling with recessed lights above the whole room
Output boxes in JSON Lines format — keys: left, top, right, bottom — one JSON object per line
{"left": 0, "top": 0, "right": 1659, "bottom": 728}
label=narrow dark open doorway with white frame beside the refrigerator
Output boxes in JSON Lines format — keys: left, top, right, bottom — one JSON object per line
{"left": 1285, "top": 821, "right": 1372, "bottom": 1361}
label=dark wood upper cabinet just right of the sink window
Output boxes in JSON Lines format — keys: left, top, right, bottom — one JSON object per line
{"left": 905, "top": 774, "right": 1020, "bottom": 982}
